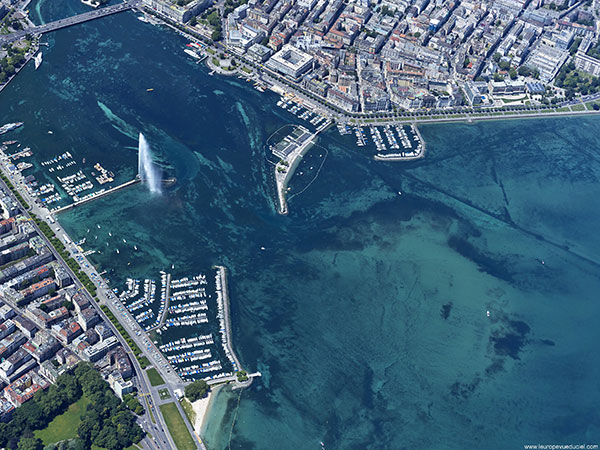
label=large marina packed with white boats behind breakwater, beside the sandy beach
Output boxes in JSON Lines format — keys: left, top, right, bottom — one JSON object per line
{"left": 113, "top": 267, "right": 240, "bottom": 381}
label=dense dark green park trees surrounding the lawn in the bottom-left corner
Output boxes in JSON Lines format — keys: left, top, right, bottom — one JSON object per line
{"left": 0, "top": 362, "right": 144, "bottom": 450}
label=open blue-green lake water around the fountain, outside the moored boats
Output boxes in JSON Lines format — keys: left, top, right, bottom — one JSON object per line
{"left": 0, "top": 2, "right": 600, "bottom": 450}
